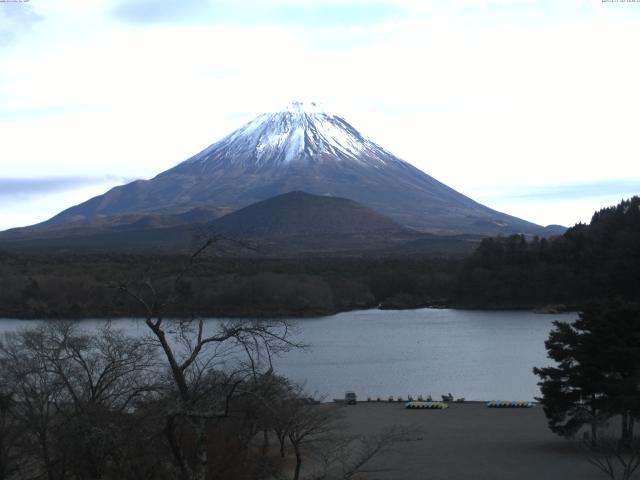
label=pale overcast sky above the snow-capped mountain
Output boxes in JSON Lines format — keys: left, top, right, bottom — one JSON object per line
{"left": 0, "top": 0, "right": 640, "bottom": 229}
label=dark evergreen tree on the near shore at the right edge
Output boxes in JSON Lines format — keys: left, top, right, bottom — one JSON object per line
{"left": 534, "top": 301, "right": 640, "bottom": 444}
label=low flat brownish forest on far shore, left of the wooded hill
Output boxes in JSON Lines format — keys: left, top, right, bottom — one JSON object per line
{"left": 0, "top": 253, "right": 459, "bottom": 318}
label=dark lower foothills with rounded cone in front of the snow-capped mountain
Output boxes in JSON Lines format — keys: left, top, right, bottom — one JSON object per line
{"left": 0, "top": 192, "right": 477, "bottom": 257}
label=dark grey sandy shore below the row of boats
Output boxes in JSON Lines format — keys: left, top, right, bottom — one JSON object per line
{"left": 344, "top": 402, "right": 606, "bottom": 480}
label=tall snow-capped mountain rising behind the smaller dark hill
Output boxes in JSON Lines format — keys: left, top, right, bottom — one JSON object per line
{"left": 16, "top": 102, "right": 556, "bottom": 242}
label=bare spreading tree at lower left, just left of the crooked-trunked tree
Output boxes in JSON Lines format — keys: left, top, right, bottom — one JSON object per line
{"left": 39, "top": 322, "right": 158, "bottom": 478}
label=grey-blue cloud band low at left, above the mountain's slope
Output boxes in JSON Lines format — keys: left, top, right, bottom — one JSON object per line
{"left": 0, "top": 176, "right": 131, "bottom": 201}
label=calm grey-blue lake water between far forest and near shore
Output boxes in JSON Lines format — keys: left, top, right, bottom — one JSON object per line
{"left": 0, "top": 309, "right": 576, "bottom": 400}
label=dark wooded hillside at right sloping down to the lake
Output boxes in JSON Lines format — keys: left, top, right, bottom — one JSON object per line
{"left": 455, "top": 197, "right": 640, "bottom": 307}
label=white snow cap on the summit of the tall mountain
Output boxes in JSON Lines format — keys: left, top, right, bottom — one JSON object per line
{"left": 178, "top": 101, "right": 404, "bottom": 170}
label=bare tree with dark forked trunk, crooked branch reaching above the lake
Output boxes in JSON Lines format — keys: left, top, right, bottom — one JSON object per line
{"left": 119, "top": 238, "right": 296, "bottom": 480}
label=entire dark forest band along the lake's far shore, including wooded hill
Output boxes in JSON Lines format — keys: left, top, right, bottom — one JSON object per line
{"left": 0, "top": 197, "right": 640, "bottom": 318}
